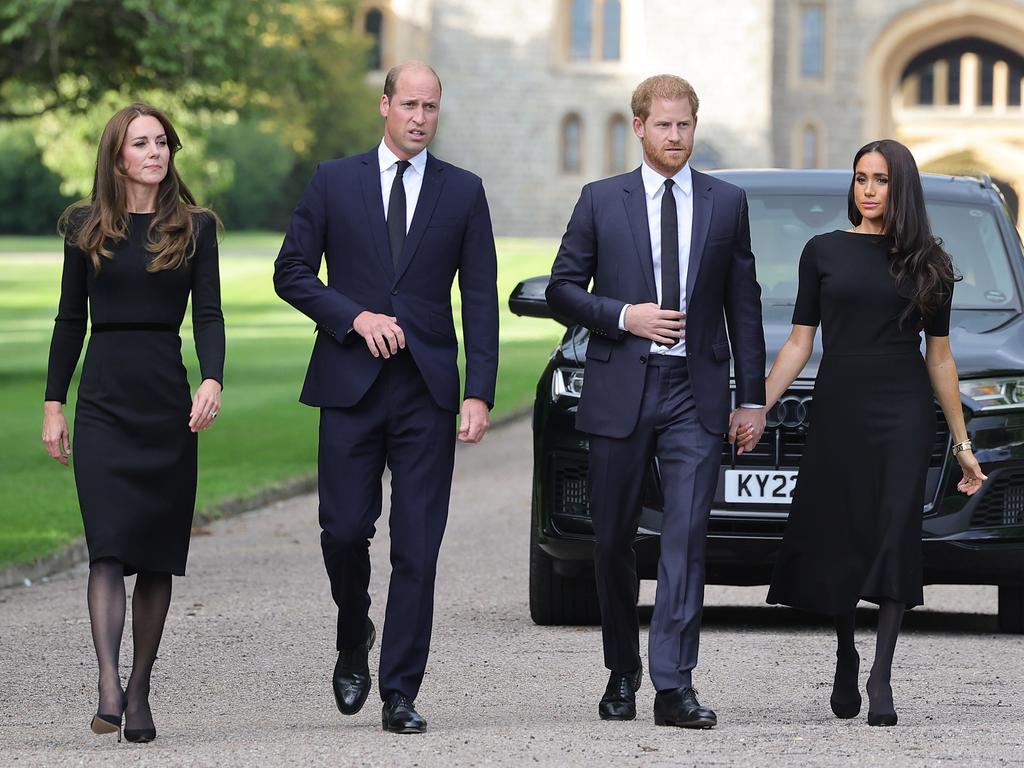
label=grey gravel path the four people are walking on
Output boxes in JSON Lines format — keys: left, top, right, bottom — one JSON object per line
{"left": 0, "top": 421, "right": 1024, "bottom": 767}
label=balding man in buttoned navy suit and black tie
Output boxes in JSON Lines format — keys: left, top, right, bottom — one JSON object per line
{"left": 273, "top": 62, "right": 498, "bottom": 733}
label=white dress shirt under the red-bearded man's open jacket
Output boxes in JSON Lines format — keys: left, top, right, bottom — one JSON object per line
{"left": 618, "top": 163, "right": 693, "bottom": 357}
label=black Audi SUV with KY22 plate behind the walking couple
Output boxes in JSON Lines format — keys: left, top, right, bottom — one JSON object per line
{"left": 509, "top": 170, "right": 1024, "bottom": 633}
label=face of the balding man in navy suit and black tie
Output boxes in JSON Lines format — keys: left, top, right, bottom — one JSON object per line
{"left": 381, "top": 69, "right": 441, "bottom": 160}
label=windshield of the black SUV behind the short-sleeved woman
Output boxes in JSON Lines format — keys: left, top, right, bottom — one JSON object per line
{"left": 749, "top": 194, "right": 1017, "bottom": 310}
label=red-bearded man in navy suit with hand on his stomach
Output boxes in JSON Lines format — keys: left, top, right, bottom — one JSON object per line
{"left": 547, "top": 75, "right": 765, "bottom": 728}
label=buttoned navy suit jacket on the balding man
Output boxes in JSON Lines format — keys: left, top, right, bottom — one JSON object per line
{"left": 273, "top": 147, "right": 498, "bottom": 413}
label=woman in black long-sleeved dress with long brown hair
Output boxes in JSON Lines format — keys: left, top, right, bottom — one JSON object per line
{"left": 43, "top": 103, "right": 224, "bottom": 741}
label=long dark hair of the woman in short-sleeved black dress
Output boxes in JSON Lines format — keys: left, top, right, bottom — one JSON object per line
{"left": 847, "top": 138, "right": 961, "bottom": 325}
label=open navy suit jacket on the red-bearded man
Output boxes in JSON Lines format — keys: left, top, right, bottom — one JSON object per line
{"left": 547, "top": 168, "right": 765, "bottom": 437}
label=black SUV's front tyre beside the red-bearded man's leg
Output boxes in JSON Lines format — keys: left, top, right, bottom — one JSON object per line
{"left": 529, "top": 499, "right": 601, "bottom": 626}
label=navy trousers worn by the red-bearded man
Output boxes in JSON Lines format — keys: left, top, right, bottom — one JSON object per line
{"left": 590, "top": 355, "right": 722, "bottom": 690}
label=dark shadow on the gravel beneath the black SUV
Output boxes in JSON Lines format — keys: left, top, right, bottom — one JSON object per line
{"left": 639, "top": 605, "right": 998, "bottom": 635}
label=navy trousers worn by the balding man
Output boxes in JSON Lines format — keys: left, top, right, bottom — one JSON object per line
{"left": 318, "top": 350, "right": 456, "bottom": 699}
